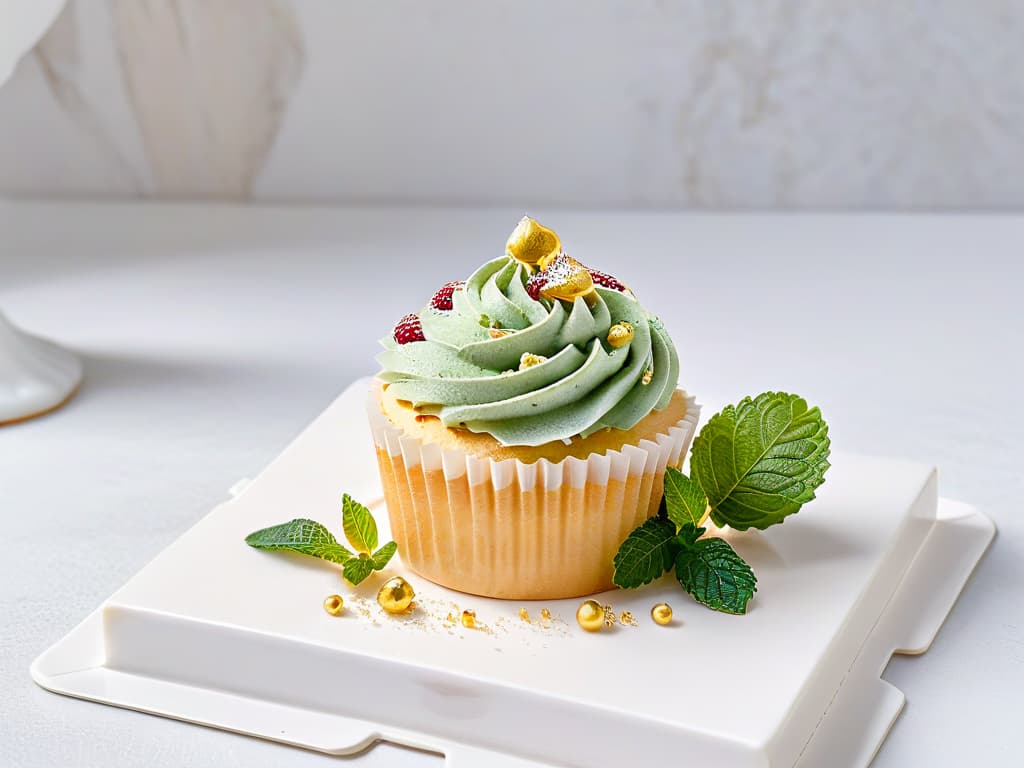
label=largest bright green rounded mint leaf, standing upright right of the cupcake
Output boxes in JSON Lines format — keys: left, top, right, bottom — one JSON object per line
{"left": 690, "top": 392, "right": 829, "bottom": 530}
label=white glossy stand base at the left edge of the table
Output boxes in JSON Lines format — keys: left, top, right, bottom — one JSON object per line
{"left": 0, "top": 312, "right": 82, "bottom": 426}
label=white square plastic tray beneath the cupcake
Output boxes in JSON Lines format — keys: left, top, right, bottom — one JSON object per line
{"left": 32, "top": 381, "right": 994, "bottom": 768}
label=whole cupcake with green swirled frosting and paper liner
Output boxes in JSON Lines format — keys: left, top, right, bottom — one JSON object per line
{"left": 368, "top": 217, "right": 698, "bottom": 600}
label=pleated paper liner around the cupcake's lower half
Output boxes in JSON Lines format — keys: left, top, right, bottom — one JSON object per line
{"left": 368, "top": 385, "right": 700, "bottom": 599}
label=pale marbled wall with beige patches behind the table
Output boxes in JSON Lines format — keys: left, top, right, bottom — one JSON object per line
{"left": 0, "top": 0, "right": 1024, "bottom": 209}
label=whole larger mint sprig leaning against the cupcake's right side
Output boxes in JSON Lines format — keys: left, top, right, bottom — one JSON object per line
{"left": 612, "top": 392, "right": 830, "bottom": 613}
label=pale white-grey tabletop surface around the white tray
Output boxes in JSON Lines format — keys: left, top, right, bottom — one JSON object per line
{"left": 0, "top": 203, "right": 1024, "bottom": 768}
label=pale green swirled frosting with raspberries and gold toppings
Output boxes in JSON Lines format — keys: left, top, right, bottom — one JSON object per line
{"left": 377, "top": 217, "right": 679, "bottom": 445}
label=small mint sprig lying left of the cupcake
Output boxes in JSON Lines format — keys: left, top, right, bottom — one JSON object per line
{"left": 246, "top": 494, "right": 398, "bottom": 585}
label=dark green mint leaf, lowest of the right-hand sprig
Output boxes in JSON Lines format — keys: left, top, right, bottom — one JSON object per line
{"left": 676, "top": 525, "right": 758, "bottom": 613}
